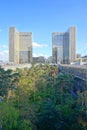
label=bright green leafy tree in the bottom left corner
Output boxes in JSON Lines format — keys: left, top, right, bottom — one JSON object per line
{"left": 0, "top": 103, "right": 19, "bottom": 130}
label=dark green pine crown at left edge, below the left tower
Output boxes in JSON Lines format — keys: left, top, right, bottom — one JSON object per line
{"left": 0, "top": 67, "right": 18, "bottom": 97}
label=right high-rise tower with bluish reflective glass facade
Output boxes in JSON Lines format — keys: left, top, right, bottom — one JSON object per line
{"left": 52, "top": 27, "right": 76, "bottom": 64}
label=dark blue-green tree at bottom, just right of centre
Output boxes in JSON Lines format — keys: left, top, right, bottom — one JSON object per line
{"left": 37, "top": 101, "right": 62, "bottom": 130}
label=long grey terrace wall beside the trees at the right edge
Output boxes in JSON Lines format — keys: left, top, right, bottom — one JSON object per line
{"left": 59, "top": 65, "right": 87, "bottom": 92}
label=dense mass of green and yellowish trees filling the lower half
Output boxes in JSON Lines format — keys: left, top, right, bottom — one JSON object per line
{"left": 0, "top": 64, "right": 87, "bottom": 130}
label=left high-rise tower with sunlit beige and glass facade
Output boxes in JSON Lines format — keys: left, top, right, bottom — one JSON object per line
{"left": 9, "top": 27, "right": 32, "bottom": 64}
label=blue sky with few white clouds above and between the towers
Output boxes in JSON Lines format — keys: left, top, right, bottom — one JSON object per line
{"left": 0, "top": 0, "right": 87, "bottom": 60}
